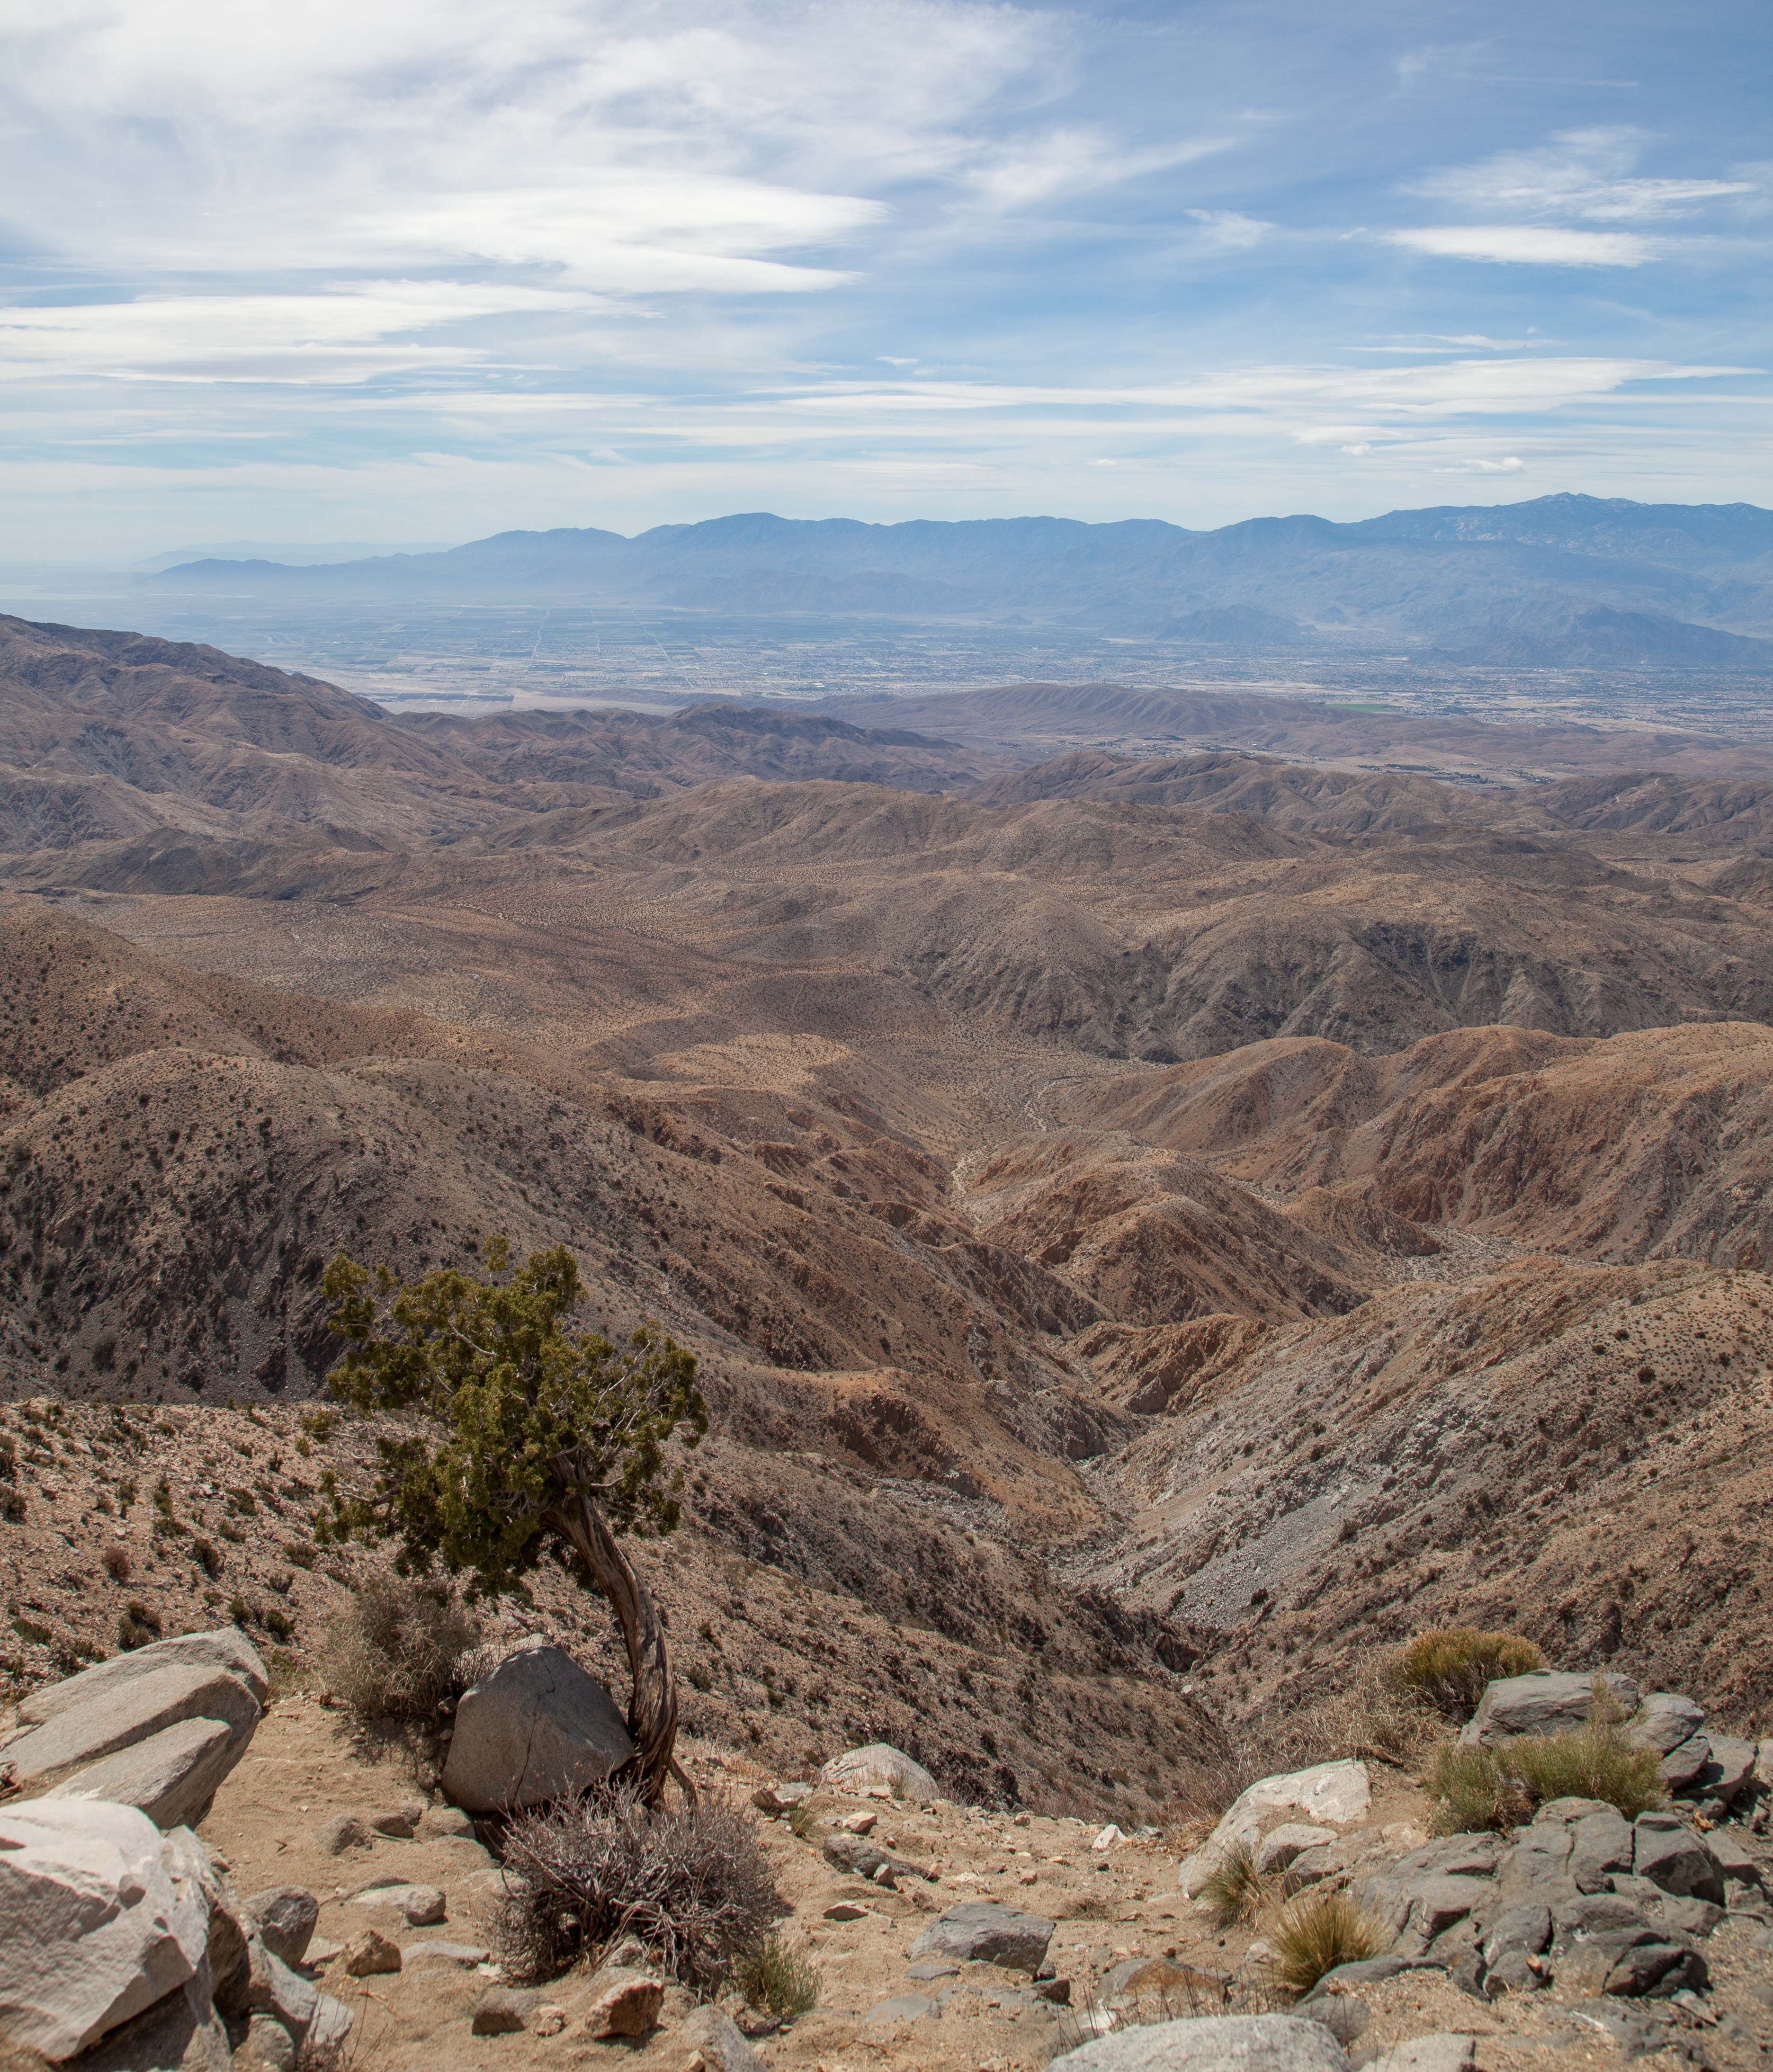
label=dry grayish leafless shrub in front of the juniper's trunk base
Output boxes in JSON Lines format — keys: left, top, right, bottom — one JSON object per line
{"left": 495, "top": 1786, "right": 783, "bottom": 1987}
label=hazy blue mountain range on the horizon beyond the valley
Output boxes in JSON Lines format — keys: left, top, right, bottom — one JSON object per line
{"left": 147, "top": 495, "right": 1773, "bottom": 669}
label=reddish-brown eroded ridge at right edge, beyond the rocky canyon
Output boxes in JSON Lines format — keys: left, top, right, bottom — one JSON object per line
{"left": 1067, "top": 1021, "right": 1773, "bottom": 1266}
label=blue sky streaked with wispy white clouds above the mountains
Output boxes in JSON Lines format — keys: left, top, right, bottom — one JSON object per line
{"left": 0, "top": 0, "right": 1773, "bottom": 560}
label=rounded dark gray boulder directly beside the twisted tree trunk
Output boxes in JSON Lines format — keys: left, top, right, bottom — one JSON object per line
{"left": 443, "top": 1643, "right": 634, "bottom": 1813}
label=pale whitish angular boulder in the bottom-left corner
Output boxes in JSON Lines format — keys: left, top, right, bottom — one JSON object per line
{"left": 0, "top": 1798, "right": 214, "bottom": 2060}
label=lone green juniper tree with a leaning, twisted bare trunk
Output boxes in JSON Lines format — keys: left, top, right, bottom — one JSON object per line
{"left": 315, "top": 1239, "right": 708, "bottom": 1804}
